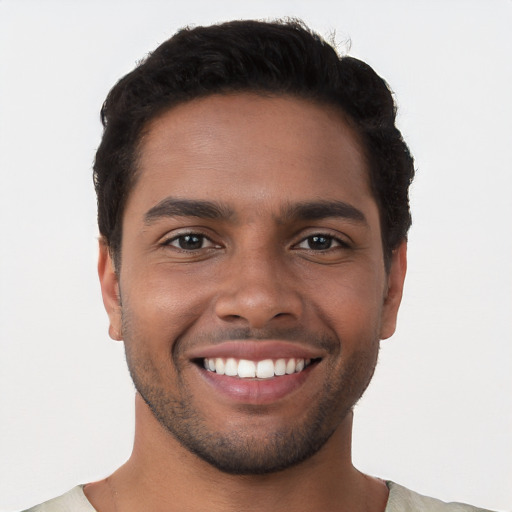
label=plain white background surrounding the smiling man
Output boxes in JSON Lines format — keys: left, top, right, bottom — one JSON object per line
{"left": 0, "top": 0, "right": 512, "bottom": 512}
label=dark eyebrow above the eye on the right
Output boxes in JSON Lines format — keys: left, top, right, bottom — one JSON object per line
{"left": 281, "top": 201, "right": 368, "bottom": 224}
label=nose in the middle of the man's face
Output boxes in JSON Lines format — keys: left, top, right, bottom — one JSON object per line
{"left": 215, "top": 251, "right": 302, "bottom": 329}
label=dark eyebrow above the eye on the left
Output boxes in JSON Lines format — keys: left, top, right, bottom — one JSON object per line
{"left": 144, "top": 197, "right": 233, "bottom": 224}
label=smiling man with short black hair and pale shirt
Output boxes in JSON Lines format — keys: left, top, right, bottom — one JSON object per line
{"left": 23, "top": 22, "right": 492, "bottom": 512}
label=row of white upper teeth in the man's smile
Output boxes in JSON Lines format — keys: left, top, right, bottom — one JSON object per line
{"left": 203, "top": 357, "right": 311, "bottom": 379}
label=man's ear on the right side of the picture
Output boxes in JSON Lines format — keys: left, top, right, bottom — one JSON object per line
{"left": 380, "top": 241, "right": 407, "bottom": 340}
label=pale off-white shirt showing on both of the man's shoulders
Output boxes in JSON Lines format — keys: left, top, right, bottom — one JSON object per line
{"left": 21, "top": 481, "right": 496, "bottom": 512}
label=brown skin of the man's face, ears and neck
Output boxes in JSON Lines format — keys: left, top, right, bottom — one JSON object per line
{"left": 89, "top": 94, "right": 406, "bottom": 512}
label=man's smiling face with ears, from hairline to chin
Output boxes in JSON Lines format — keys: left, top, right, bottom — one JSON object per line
{"left": 99, "top": 94, "right": 405, "bottom": 474}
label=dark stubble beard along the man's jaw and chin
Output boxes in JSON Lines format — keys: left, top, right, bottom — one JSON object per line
{"left": 123, "top": 316, "right": 379, "bottom": 475}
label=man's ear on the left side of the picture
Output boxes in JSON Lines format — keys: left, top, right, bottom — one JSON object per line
{"left": 98, "top": 238, "right": 123, "bottom": 341}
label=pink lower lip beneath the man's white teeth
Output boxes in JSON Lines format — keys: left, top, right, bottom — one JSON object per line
{"left": 198, "top": 364, "right": 316, "bottom": 405}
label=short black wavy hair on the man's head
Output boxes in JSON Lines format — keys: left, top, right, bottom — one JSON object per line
{"left": 94, "top": 20, "right": 414, "bottom": 268}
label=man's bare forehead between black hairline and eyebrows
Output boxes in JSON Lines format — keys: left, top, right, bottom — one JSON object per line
{"left": 127, "top": 93, "right": 373, "bottom": 220}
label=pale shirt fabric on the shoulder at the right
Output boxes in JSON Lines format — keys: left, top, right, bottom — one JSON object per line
{"left": 385, "top": 482, "right": 496, "bottom": 512}
